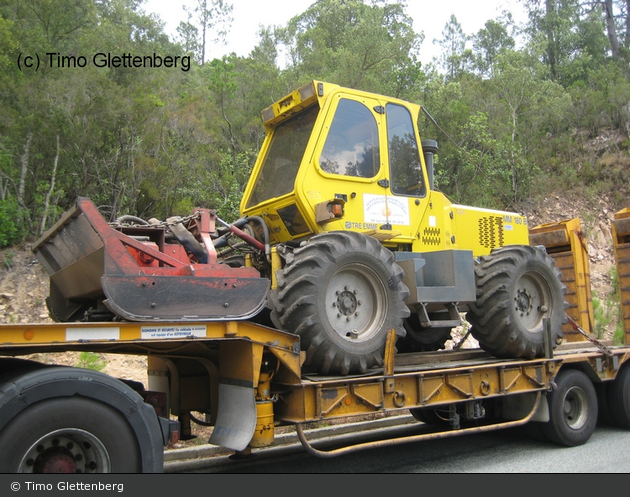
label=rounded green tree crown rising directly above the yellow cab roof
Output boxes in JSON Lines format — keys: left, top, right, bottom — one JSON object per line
{"left": 278, "top": 0, "right": 422, "bottom": 93}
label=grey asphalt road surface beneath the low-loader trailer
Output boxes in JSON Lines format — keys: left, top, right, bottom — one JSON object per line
{"left": 165, "top": 414, "right": 630, "bottom": 474}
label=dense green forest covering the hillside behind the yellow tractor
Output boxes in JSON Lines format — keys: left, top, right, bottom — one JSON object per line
{"left": 0, "top": 0, "right": 630, "bottom": 247}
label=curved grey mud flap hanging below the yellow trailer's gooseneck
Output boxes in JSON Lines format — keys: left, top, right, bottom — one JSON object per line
{"left": 210, "top": 379, "right": 256, "bottom": 451}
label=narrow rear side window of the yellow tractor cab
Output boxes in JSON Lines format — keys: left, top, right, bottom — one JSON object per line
{"left": 386, "top": 104, "right": 427, "bottom": 197}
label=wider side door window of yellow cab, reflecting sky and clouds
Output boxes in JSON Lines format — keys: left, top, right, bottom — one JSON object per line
{"left": 319, "top": 98, "right": 380, "bottom": 178}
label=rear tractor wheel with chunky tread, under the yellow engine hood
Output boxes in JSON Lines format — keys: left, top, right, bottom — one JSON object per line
{"left": 467, "top": 245, "right": 568, "bottom": 359}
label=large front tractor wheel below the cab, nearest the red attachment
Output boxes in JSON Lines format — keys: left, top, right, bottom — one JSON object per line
{"left": 270, "top": 231, "right": 409, "bottom": 375}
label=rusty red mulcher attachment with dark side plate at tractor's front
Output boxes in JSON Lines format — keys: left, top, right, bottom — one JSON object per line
{"left": 33, "top": 197, "right": 269, "bottom": 321}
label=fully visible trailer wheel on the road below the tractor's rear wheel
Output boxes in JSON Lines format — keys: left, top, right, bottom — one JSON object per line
{"left": 541, "top": 369, "right": 597, "bottom": 447}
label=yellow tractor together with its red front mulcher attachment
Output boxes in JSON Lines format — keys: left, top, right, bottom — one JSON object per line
{"left": 34, "top": 81, "right": 568, "bottom": 375}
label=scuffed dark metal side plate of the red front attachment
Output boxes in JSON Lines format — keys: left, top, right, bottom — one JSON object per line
{"left": 101, "top": 275, "right": 269, "bottom": 321}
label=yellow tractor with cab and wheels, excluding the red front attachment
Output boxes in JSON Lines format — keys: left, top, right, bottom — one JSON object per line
{"left": 241, "top": 81, "right": 567, "bottom": 374}
